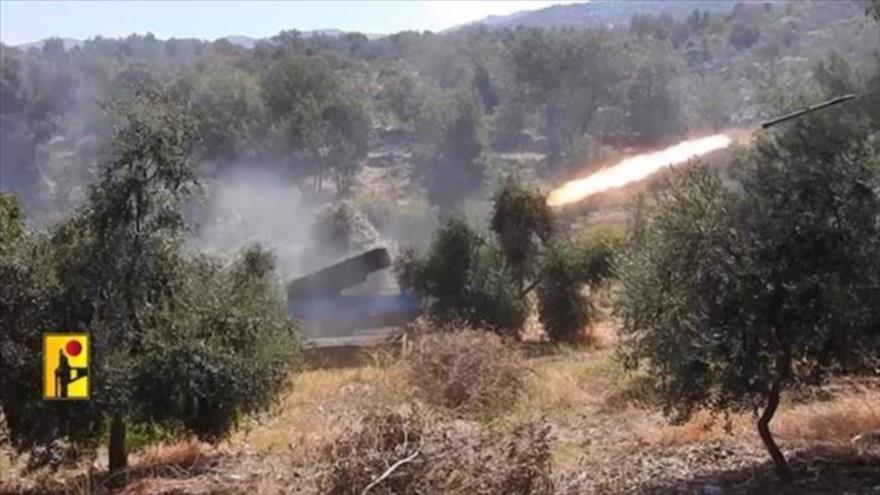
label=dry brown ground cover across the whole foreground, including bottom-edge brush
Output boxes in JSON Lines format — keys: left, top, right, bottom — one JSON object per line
{"left": 0, "top": 329, "right": 880, "bottom": 495}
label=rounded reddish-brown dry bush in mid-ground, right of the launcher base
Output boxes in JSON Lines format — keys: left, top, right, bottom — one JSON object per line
{"left": 408, "top": 330, "right": 526, "bottom": 413}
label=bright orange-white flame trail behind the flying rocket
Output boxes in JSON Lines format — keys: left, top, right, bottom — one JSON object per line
{"left": 547, "top": 134, "right": 733, "bottom": 206}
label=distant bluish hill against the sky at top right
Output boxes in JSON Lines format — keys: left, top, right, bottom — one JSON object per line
{"left": 458, "top": 0, "right": 739, "bottom": 31}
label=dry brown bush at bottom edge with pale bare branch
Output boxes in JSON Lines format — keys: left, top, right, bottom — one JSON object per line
{"left": 320, "top": 410, "right": 553, "bottom": 495}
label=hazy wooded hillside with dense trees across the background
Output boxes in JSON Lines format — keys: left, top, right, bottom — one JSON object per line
{"left": 0, "top": 2, "right": 874, "bottom": 220}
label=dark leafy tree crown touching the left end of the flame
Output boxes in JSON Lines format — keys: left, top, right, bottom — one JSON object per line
{"left": 490, "top": 176, "right": 553, "bottom": 286}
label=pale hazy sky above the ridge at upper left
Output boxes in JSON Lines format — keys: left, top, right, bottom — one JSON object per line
{"left": 0, "top": 0, "right": 571, "bottom": 45}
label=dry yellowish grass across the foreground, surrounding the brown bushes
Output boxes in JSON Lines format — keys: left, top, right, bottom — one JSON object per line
{"left": 0, "top": 328, "right": 880, "bottom": 495}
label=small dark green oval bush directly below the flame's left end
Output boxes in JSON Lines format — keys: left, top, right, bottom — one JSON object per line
{"left": 538, "top": 242, "right": 592, "bottom": 342}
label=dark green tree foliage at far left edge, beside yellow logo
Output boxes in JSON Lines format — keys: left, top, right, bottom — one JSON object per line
{"left": 0, "top": 205, "right": 102, "bottom": 464}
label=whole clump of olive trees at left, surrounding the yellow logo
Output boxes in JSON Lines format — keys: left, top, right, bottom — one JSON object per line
{"left": 0, "top": 93, "right": 298, "bottom": 482}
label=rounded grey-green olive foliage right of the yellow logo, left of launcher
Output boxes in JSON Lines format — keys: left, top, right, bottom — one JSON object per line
{"left": 135, "top": 246, "right": 299, "bottom": 438}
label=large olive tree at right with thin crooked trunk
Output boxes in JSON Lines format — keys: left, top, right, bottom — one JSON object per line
{"left": 617, "top": 114, "right": 880, "bottom": 478}
